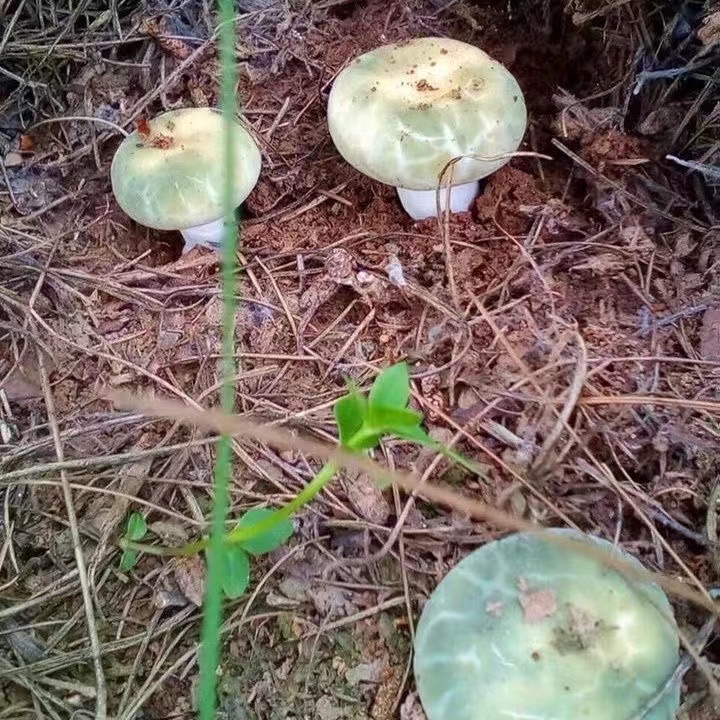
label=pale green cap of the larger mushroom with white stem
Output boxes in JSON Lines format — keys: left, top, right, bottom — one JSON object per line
{"left": 327, "top": 37, "right": 527, "bottom": 190}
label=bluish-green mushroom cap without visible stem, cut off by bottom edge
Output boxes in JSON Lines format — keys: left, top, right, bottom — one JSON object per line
{"left": 414, "top": 530, "right": 680, "bottom": 720}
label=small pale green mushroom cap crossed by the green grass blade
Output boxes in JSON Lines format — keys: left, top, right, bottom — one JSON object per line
{"left": 110, "top": 108, "right": 261, "bottom": 230}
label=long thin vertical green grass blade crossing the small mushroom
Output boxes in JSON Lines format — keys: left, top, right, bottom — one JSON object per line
{"left": 198, "top": 0, "right": 237, "bottom": 720}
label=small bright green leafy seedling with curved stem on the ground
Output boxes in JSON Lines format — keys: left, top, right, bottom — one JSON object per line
{"left": 120, "top": 363, "right": 481, "bottom": 598}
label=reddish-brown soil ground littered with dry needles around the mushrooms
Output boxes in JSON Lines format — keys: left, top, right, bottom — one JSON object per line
{"left": 0, "top": 0, "right": 720, "bottom": 720}
